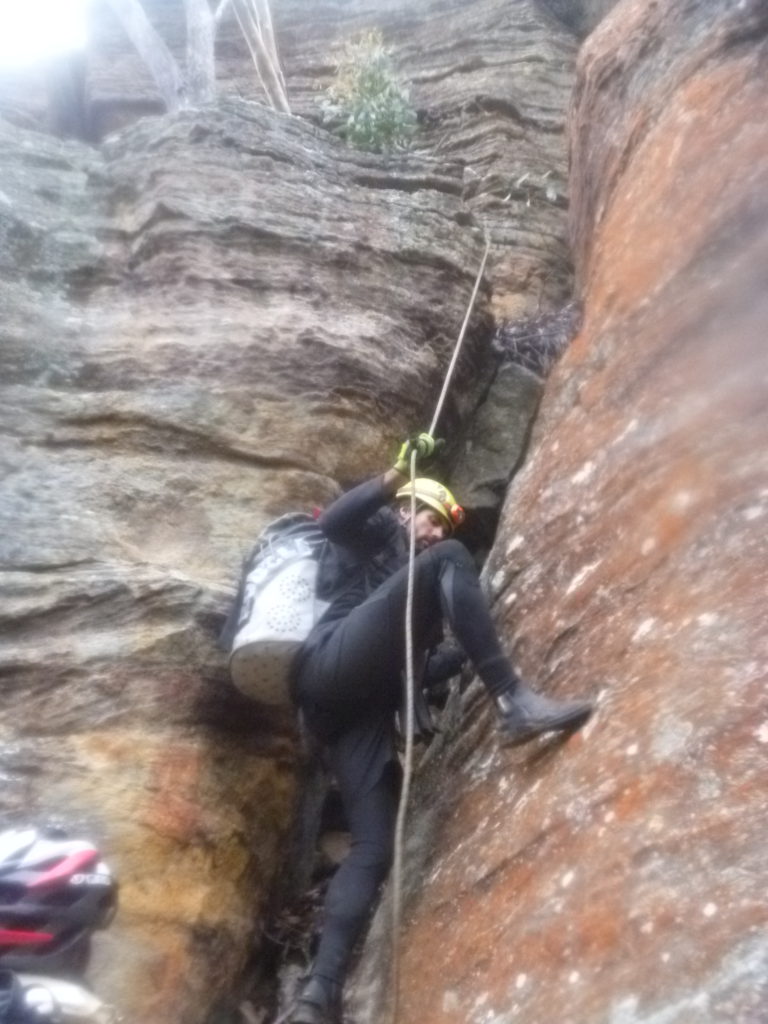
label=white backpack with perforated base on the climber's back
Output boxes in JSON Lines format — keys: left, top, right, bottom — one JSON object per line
{"left": 222, "top": 512, "right": 329, "bottom": 705}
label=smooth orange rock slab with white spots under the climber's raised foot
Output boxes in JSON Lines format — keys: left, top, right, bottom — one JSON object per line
{"left": 355, "top": 0, "right": 768, "bottom": 1024}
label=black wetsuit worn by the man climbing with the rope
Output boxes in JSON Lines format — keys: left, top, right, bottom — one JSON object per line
{"left": 293, "top": 477, "right": 515, "bottom": 981}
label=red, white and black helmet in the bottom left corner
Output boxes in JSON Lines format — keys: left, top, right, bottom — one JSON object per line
{"left": 0, "top": 828, "right": 117, "bottom": 971}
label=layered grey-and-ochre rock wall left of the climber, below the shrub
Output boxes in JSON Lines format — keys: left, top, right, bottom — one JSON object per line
{"left": 0, "top": 101, "right": 487, "bottom": 1024}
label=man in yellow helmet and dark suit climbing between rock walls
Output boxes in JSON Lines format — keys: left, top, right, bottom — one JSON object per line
{"left": 290, "top": 433, "right": 592, "bottom": 1024}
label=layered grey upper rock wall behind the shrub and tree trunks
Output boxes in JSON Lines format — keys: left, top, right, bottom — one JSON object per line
{"left": 0, "top": 0, "right": 581, "bottom": 315}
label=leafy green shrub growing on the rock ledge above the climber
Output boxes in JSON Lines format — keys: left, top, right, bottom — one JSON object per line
{"left": 321, "top": 30, "right": 416, "bottom": 153}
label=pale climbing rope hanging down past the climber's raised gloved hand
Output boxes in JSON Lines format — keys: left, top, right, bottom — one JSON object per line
{"left": 391, "top": 238, "right": 490, "bottom": 1024}
